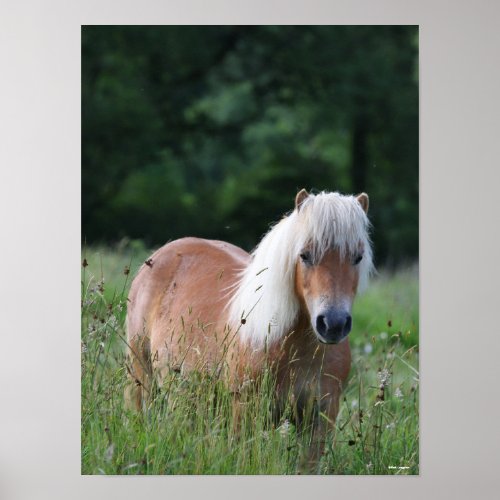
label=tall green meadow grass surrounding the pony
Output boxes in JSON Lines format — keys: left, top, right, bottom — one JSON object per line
{"left": 81, "top": 242, "right": 419, "bottom": 474}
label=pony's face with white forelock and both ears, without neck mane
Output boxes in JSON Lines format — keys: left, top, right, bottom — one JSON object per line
{"left": 295, "top": 189, "right": 372, "bottom": 344}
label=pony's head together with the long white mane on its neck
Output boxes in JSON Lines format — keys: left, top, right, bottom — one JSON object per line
{"left": 230, "top": 189, "right": 372, "bottom": 346}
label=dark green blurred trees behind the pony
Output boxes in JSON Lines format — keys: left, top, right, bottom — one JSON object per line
{"left": 82, "top": 26, "right": 418, "bottom": 267}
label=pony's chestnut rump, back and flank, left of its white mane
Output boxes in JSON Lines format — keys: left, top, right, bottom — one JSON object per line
{"left": 127, "top": 238, "right": 249, "bottom": 404}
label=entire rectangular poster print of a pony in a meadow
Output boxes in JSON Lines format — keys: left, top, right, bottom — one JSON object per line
{"left": 81, "top": 24, "right": 420, "bottom": 474}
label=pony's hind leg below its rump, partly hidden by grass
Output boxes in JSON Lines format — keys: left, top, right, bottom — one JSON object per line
{"left": 125, "top": 335, "right": 153, "bottom": 411}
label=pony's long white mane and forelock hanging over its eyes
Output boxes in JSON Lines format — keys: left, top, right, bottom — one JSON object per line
{"left": 229, "top": 192, "right": 373, "bottom": 347}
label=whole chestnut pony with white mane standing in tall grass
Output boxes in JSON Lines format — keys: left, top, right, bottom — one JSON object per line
{"left": 127, "top": 190, "right": 372, "bottom": 460}
